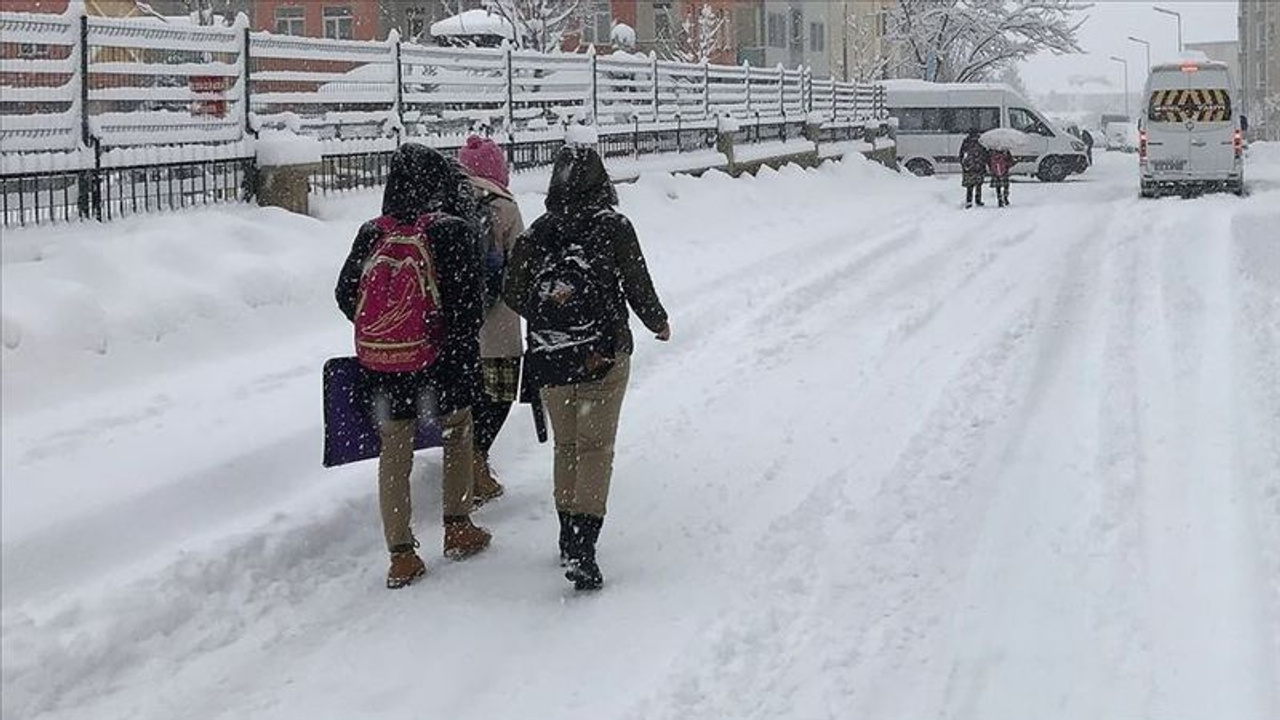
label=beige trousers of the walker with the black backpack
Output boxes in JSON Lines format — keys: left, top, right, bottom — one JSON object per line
{"left": 543, "top": 355, "right": 631, "bottom": 518}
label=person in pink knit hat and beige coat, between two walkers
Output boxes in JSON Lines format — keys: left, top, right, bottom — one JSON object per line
{"left": 458, "top": 136, "right": 525, "bottom": 506}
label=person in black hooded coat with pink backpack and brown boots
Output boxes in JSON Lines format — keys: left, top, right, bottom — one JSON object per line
{"left": 334, "top": 143, "right": 490, "bottom": 588}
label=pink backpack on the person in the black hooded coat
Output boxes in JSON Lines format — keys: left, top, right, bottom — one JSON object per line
{"left": 356, "top": 215, "right": 444, "bottom": 373}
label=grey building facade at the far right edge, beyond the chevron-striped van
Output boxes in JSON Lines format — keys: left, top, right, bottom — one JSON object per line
{"left": 1236, "top": 0, "right": 1280, "bottom": 140}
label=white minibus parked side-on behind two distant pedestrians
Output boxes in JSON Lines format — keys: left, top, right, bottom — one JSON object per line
{"left": 883, "top": 79, "right": 1089, "bottom": 182}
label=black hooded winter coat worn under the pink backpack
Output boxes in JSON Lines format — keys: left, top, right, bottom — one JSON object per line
{"left": 334, "top": 143, "right": 484, "bottom": 419}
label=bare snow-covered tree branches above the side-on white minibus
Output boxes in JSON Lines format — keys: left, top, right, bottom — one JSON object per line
{"left": 887, "top": 0, "right": 1092, "bottom": 82}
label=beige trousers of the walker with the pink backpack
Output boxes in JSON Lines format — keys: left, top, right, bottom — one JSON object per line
{"left": 378, "top": 407, "right": 475, "bottom": 551}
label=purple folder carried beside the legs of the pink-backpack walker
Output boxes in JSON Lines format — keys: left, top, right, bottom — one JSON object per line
{"left": 324, "top": 357, "right": 443, "bottom": 468}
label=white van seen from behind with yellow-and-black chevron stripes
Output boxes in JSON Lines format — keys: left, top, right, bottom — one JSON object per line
{"left": 1138, "top": 60, "right": 1244, "bottom": 197}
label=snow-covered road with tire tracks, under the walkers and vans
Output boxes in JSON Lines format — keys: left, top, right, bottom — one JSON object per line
{"left": 3, "top": 146, "right": 1280, "bottom": 720}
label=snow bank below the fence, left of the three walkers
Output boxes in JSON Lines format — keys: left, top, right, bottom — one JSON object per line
{"left": 0, "top": 206, "right": 355, "bottom": 411}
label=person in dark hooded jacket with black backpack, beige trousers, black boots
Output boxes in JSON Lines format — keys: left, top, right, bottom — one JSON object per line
{"left": 503, "top": 146, "right": 671, "bottom": 591}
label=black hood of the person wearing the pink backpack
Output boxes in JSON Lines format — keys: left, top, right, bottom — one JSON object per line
{"left": 383, "top": 142, "right": 475, "bottom": 220}
